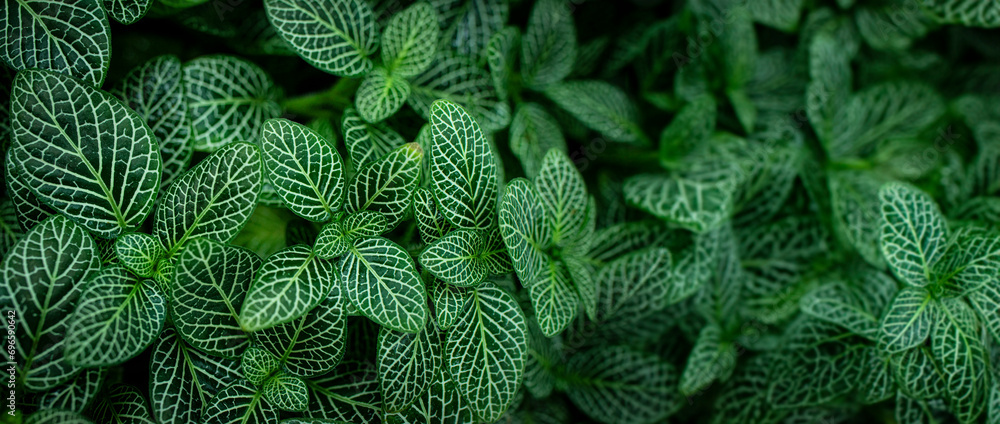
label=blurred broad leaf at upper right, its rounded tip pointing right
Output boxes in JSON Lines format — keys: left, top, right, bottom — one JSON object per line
{"left": 827, "top": 82, "right": 945, "bottom": 158}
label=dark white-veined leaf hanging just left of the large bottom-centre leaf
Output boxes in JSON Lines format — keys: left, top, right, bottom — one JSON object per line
{"left": 378, "top": 320, "right": 441, "bottom": 412}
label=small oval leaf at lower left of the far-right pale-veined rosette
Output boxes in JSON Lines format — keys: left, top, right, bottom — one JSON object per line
{"left": 879, "top": 287, "right": 934, "bottom": 353}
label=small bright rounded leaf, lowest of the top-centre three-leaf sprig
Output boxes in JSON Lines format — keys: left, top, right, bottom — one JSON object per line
{"left": 354, "top": 67, "right": 410, "bottom": 122}
